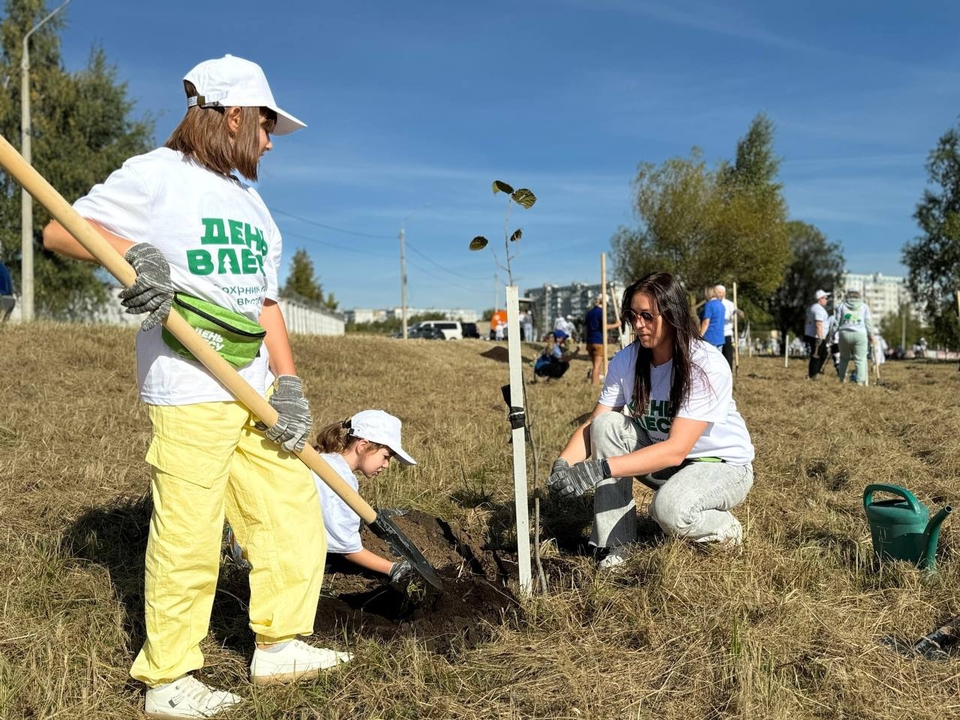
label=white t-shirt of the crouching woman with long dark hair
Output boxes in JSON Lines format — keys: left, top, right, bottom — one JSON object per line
{"left": 598, "top": 340, "right": 754, "bottom": 465}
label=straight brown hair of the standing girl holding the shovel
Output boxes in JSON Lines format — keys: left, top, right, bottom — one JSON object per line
{"left": 164, "top": 80, "right": 277, "bottom": 181}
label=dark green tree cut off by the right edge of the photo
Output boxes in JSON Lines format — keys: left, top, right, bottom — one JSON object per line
{"left": 903, "top": 126, "right": 960, "bottom": 347}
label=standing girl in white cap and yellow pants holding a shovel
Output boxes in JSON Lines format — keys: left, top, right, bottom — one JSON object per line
{"left": 44, "top": 55, "right": 349, "bottom": 718}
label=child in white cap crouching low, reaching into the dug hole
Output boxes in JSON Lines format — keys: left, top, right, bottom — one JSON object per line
{"left": 313, "top": 410, "right": 417, "bottom": 586}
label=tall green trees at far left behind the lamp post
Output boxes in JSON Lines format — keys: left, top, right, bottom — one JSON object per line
{"left": 0, "top": 0, "right": 154, "bottom": 318}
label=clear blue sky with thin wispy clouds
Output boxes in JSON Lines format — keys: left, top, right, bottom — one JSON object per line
{"left": 50, "top": 0, "right": 960, "bottom": 310}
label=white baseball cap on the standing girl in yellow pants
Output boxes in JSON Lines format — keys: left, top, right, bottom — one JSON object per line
{"left": 183, "top": 55, "right": 306, "bottom": 135}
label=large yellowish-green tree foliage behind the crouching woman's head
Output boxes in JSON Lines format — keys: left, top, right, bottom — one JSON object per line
{"left": 612, "top": 115, "right": 789, "bottom": 305}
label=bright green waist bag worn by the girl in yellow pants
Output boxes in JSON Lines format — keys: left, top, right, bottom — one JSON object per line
{"left": 162, "top": 293, "right": 267, "bottom": 367}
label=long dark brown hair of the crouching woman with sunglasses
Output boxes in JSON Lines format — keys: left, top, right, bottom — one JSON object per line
{"left": 620, "top": 272, "right": 703, "bottom": 416}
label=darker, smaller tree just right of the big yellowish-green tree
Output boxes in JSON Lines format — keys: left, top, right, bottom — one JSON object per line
{"left": 768, "top": 220, "right": 844, "bottom": 337}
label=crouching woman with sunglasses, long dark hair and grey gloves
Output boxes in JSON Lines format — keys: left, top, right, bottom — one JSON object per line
{"left": 547, "top": 272, "right": 754, "bottom": 569}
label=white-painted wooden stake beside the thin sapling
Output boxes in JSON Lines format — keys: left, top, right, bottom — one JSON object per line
{"left": 507, "top": 285, "right": 533, "bottom": 595}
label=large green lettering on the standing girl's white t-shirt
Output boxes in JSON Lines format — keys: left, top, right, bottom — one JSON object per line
{"left": 187, "top": 218, "right": 267, "bottom": 275}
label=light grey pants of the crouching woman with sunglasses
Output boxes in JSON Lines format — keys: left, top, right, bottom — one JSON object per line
{"left": 590, "top": 412, "right": 753, "bottom": 547}
